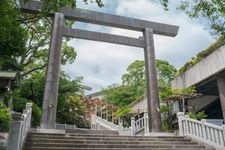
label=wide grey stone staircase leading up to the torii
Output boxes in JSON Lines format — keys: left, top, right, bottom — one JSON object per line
{"left": 23, "top": 130, "right": 213, "bottom": 150}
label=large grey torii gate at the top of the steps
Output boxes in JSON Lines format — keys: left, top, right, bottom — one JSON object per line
{"left": 21, "top": 1, "right": 178, "bottom": 132}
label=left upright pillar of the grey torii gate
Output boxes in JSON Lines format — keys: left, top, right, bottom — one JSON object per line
{"left": 41, "top": 13, "right": 64, "bottom": 129}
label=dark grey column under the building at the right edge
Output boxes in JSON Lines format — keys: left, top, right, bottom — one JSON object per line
{"left": 217, "top": 72, "right": 225, "bottom": 121}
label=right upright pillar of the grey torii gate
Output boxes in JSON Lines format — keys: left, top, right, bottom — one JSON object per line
{"left": 144, "top": 28, "right": 161, "bottom": 132}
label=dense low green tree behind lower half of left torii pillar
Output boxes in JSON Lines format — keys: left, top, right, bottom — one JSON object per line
{"left": 13, "top": 71, "right": 85, "bottom": 126}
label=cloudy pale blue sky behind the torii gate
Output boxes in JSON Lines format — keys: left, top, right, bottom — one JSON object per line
{"left": 64, "top": 0, "right": 213, "bottom": 93}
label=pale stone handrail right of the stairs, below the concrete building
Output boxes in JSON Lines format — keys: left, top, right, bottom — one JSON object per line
{"left": 177, "top": 112, "right": 225, "bottom": 150}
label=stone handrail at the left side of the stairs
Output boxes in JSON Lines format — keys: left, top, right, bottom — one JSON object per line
{"left": 7, "top": 103, "right": 32, "bottom": 150}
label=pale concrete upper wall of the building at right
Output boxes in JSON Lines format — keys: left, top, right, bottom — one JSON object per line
{"left": 172, "top": 45, "right": 225, "bottom": 89}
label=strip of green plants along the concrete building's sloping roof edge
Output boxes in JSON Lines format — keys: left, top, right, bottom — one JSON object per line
{"left": 178, "top": 36, "right": 225, "bottom": 74}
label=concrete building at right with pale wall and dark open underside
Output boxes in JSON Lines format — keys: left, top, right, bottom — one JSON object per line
{"left": 172, "top": 45, "right": 225, "bottom": 119}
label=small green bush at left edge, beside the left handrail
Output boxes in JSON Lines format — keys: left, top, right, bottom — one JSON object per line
{"left": 0, "top": 102, "right": 12, "bottom": 132}
